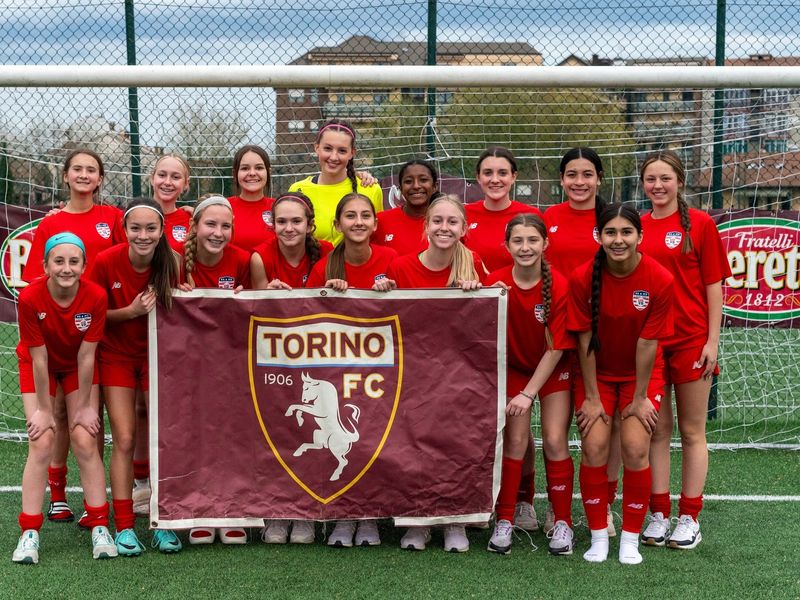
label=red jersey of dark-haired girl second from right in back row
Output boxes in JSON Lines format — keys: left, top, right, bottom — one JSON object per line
{"left": 544, "top": 202, "right": 600, "bottom": 276}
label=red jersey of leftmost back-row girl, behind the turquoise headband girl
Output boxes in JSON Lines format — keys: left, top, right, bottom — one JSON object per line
{"left": 22, "top": 204, "right": 128, "bottom": 283}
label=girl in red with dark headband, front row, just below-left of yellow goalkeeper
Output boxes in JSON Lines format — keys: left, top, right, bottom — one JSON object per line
{"left": 250, "top": 192, "right": 333, "bottom": 290}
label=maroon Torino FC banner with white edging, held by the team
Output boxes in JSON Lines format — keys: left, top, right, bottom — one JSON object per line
{"left": 150, "top": 288, "right": 506, "bottom": 528}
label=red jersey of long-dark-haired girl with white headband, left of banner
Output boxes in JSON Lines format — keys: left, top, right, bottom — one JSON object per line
{"left": 92, "top": 244, "right": 150, "bottom": 360}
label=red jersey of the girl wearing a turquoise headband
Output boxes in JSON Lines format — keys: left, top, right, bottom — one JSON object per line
{"left": 17, "top": 277, "right": 108, "bottom": 373}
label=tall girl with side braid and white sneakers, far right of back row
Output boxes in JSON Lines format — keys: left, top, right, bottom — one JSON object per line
{"left": 640, "top": 150, "right": 731, "bottom": 550}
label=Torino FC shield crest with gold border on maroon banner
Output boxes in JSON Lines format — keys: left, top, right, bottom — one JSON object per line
{"left": 249, "top": 313, "right": 403, "bottom": 504}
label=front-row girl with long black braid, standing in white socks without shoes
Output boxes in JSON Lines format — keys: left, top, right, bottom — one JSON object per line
{"left": 567, "top": 204, "right": 674, "bottom": 564}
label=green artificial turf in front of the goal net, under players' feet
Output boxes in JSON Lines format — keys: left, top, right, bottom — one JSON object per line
{"left": 0, "top": 441, "right": 800, "bottom": 600}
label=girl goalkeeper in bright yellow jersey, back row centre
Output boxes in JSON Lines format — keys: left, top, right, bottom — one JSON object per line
{"left": 289, "top": 119, "right": 383, "bottom": 244}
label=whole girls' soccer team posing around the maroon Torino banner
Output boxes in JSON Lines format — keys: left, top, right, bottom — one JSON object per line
{"left": 13, "top": 120, "right": 729, "bottom": 564}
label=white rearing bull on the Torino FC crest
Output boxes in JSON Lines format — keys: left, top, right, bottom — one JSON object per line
{"left": 286, "top": 373, "right": 361, "bottom": 481}
